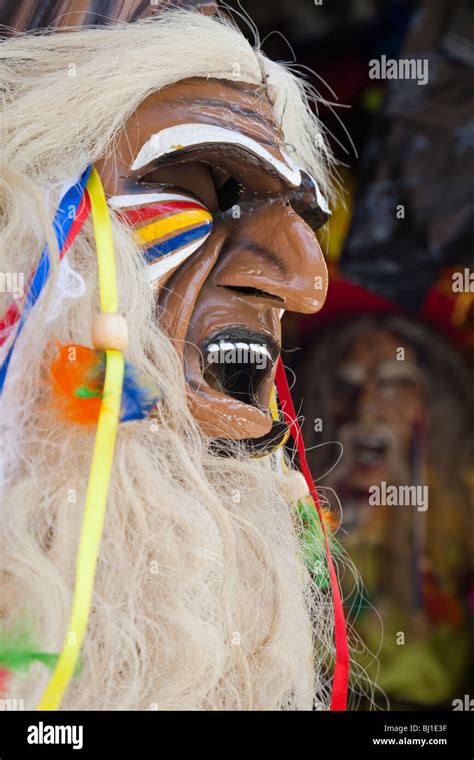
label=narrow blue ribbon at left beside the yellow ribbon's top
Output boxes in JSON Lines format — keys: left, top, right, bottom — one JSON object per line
{"left": 0, "top": 166, "right": 92, "bottom": 395}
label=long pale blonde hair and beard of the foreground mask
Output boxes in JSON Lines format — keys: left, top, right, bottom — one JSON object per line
{"left": 0, "top": 11, "right": 340, "bottom": 709}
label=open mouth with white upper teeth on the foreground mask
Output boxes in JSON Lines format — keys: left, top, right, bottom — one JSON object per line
{"left": 201, "top": 326, "right": 280, "bottom": 410}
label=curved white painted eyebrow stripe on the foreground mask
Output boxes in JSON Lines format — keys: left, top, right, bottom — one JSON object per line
{"left": 131, "top": 124, "right": 301, "bottom": 187}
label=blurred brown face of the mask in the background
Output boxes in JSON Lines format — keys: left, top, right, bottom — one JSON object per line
{"left": 326, "top": 329, "right": 427, "bottom": 502}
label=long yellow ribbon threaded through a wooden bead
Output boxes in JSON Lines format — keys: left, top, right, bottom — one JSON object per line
{"left": 37, "top": 167, "right": 124, "bottom": 710}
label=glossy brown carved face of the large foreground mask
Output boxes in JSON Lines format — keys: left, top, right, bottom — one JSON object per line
{"left": 96, "top": 78, "right": 329, "bottom": 443}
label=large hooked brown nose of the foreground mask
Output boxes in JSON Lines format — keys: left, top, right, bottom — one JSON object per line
{"left": 214, "top": 198, "right": 328, "bottom": 314}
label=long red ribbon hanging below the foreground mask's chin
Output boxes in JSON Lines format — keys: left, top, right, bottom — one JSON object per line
{"left": 275, "top": 357, "right": 349, "bottom": 710}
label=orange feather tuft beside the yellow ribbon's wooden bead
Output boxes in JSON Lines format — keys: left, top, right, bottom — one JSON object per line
{"left": 51, "top": 344, "right": 105, "bottom": 425}
